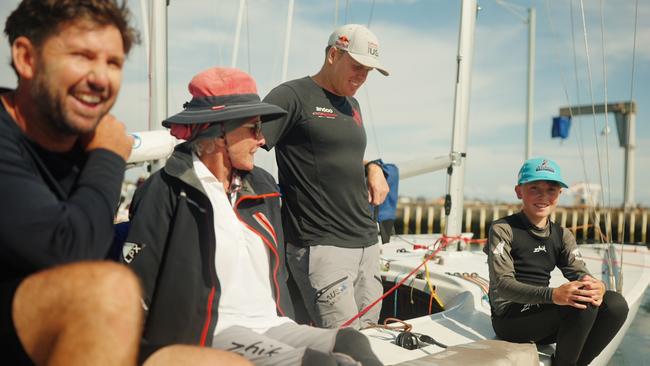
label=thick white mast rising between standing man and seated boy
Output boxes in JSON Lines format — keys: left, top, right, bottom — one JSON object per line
{"left": 445, "top": 0, "right": 478, "bottom": 249}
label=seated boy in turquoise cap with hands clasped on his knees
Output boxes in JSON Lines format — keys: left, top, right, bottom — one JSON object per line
{"left": 485, "top": 158, "right": 628, "bottom": 365}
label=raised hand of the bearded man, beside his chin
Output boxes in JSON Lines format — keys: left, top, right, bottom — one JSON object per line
{"left": 80, "top": 114, "right": 133, "bottom": 161}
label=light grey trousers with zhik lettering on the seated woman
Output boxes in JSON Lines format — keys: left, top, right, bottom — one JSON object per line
{"left": 212, "top": 323, "right": 357, "bottom": 366}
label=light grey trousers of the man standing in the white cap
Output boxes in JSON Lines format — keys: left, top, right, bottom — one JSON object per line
{"left": 286, "top": 243, "right": 383, "bottom": 329}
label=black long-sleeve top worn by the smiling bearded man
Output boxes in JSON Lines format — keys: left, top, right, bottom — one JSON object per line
{"left": 0, "top": 91, "right": 125, "bottom": 281}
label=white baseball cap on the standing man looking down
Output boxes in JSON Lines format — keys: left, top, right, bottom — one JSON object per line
{"left": 327, "top": 24, "right": 388, "bottom": 76}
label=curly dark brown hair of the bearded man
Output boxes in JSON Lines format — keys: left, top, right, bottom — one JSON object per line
{"left": 5, "top": 0, "right": 140, "bottom": 54}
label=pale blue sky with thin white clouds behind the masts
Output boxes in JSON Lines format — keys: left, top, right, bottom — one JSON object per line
{"left": 0, "top": 0, "right": 650, "bottom": 207}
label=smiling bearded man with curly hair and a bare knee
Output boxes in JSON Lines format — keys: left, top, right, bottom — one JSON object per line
{"left": 0, "top": 0, "right": 248, "bottom": 365}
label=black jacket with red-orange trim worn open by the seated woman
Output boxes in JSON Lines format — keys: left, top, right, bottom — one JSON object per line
{"left": 122, "top": 143, "right": 292, "bottom": 353}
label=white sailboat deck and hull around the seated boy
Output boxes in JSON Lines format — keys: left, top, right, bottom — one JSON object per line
{"left": 363, "top": 235, "right": 650, "bottom": 365}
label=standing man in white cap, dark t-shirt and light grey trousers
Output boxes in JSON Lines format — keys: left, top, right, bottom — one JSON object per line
{"left": 262, "top": 24, "right": 388, "bottom": 328}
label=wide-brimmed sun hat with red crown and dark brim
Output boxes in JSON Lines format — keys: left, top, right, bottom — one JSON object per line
{"left": 162, "top": 67, "right": 287, "bottom": 132}
